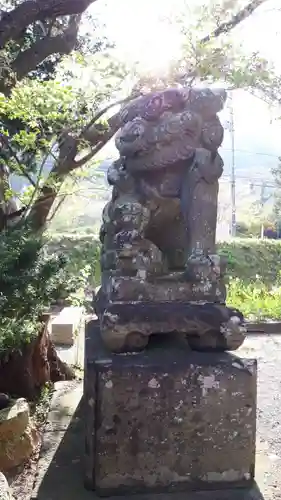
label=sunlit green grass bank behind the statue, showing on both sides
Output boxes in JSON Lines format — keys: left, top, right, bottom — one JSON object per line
{"left": 49, "top": 232, "right": 281, "bottom": 320}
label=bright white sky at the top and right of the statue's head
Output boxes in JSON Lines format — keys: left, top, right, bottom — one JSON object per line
{"left": 86, "top": 0, "right": 281, "bottom": 177}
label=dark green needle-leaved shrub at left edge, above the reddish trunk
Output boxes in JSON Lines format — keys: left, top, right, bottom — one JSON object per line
{"left": 0, "top": 226, "right": 66, "bottom": 350}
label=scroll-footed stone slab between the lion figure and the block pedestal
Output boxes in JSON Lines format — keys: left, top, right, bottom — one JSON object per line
{"left": 100, "top": 301, "right": 246, "bottom": 352}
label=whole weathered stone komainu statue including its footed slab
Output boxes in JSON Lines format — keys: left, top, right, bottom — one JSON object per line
{"left": 95, "top": 88, "right": 245, "bottom": 352}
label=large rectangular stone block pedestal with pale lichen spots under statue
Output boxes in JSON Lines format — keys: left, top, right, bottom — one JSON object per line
{"left": 85, "top": 321, "right": 256, "bottom": 496}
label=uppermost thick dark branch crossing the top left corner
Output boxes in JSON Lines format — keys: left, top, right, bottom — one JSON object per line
{"left": 0, "top": 0, "right": 95, "bottom": 48}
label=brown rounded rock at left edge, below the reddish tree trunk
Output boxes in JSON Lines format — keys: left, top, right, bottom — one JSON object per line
{"left": 0, "top": 399, "right": 40, "bottom": 472}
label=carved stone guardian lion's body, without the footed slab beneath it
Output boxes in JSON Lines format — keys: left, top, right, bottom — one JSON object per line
{"left": 97, "top": 88, "right": 226, "bottom": 300}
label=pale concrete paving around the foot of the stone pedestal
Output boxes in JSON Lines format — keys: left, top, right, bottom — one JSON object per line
{"left": 29, "top": 335, "right": 281, "bottom": 500}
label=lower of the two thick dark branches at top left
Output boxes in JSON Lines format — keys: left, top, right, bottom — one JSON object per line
{"left": 12, "top": 14, "right": 81, "bottom": 80}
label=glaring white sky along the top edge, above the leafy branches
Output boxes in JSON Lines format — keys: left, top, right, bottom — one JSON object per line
{"left": 90, "top": 0, "right": 281, "bottom": 68}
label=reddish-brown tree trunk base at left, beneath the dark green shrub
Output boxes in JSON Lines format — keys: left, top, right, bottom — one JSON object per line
{"left": 0, "top": 315, "right": 74, "bottom": 400}
